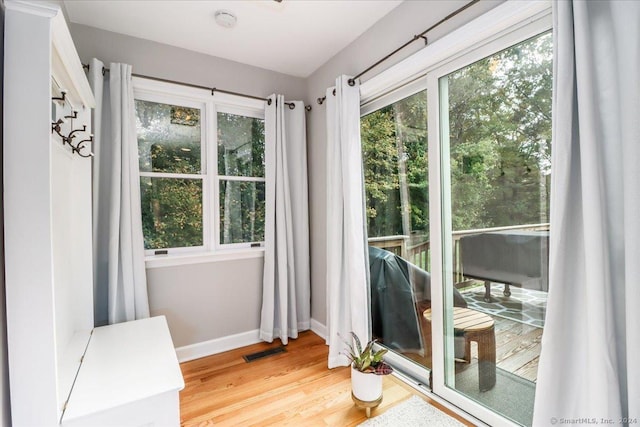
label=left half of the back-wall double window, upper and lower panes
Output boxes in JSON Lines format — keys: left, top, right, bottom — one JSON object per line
{"left": 136, "top": 100, "right": 204, "bottom": 250}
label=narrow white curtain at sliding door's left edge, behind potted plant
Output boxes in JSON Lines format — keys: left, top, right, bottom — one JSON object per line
{"left": 326, "top": 76, "right": 370, "bottom": 368}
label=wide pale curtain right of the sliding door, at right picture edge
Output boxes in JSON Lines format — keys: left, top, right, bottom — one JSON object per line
{"left": 534, "top": 0, "right": 640, "bottom": 426}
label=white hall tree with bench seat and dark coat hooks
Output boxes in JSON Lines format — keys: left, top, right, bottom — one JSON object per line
{"left": 3, "top": 0, "right": 184, "bottom": 426}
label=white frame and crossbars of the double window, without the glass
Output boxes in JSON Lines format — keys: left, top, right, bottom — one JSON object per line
{"left": 133, "top": 77, "right": 266, "bottom": 262}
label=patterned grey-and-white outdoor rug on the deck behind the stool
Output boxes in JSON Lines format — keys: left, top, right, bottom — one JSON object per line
{"left": 461, "top": 283, "right": 547, "bottom": 328}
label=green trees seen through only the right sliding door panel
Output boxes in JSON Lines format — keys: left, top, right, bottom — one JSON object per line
{"left": 448, "top": 34, "right": 552, "bottom": 230}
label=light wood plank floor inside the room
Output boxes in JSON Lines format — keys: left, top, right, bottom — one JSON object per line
{"left": 180, "top": 332, "right": 472, "bottom": 427}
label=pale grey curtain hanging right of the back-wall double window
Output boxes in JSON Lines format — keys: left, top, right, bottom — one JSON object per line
{"left": 260, "top": 95, "right": 311, "bottom": 344}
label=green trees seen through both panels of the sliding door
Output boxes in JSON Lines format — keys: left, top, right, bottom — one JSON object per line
{"left": 361, "top": 34, "right": 552, "bottom": 237}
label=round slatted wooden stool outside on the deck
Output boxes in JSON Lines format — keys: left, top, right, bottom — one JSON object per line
{"left": 423, "top": 307, "right": 496, "bottom": 391}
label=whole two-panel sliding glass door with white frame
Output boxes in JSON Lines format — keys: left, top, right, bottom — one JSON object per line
{"left": 361, "top": 6, "right": 553, "bottom": 425}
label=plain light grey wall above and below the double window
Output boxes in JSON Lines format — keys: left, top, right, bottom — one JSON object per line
{"left": 70, "top": 24, "right": 306, "bottom": 347}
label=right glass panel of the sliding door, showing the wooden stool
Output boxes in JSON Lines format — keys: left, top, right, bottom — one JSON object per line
{"left": 438, "top": 33, "right": 552, "bottom": 425}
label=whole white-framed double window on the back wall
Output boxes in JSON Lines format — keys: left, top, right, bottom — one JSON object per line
{"left": 135, "top": 79, "right": 265, "bottom": 255}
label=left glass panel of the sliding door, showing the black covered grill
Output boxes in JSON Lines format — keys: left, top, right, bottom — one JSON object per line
{"left": 361, "top": 90, "right": 431, "bottom": 380}
